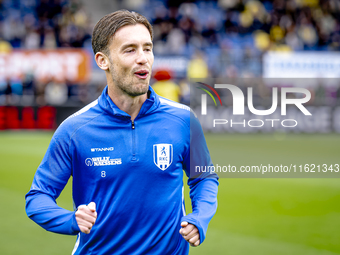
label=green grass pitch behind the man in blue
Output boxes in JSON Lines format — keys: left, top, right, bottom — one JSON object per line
{"left": 0, "top": 132, "right": 340, "bottom": 255}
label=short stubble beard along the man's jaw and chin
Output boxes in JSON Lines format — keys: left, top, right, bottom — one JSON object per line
{"left": 110, "top": 58, "right": 150, "bottom": 97}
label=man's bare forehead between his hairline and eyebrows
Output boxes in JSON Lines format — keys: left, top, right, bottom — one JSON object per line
{"left": 111, "top": 24, "right": 151, "bottom": 48}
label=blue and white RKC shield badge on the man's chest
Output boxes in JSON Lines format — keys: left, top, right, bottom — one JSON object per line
{"left": 153, "top": 143, "right": 173, "bottom": 171}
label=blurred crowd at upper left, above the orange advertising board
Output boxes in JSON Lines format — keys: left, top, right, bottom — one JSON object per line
{"left": 0, "top": 0, "right": 91, "bottom": 51}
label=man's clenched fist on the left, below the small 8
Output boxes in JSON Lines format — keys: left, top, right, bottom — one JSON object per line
{"left": 76, "top": 202, "right": 97, "bottom": 234}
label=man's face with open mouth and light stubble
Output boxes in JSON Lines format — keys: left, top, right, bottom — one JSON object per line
{"left": 109, "top": 24, "right": 154, "bottom": 97}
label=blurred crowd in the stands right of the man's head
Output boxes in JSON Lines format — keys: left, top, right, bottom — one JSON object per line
{"left": 139, "top": 0, "right": 340, "bottom": 77}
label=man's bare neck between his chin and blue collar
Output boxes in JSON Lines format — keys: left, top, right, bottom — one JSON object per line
{"left": 108, "top": 83, "right": 147, "bottom": 120}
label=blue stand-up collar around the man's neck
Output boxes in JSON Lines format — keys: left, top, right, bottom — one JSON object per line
{"left": 98, "top": 86, "right": 160, "bottom": 118}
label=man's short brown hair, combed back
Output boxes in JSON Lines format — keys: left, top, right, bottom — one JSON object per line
{"left": 92, "top": 10, "right": 153, "bottom": 55}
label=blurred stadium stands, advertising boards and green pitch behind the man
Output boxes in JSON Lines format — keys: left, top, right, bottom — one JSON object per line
{"left": 0, "top": 0, "right": 340, "bottom": 255}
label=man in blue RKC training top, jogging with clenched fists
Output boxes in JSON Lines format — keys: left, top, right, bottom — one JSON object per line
{"left": 26, "top": 11, "right": 218, "bottom": 254}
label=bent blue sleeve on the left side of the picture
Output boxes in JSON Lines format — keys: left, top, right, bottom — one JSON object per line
{"left": 26, "top": 131, "right": 79, "bottom": 235}
